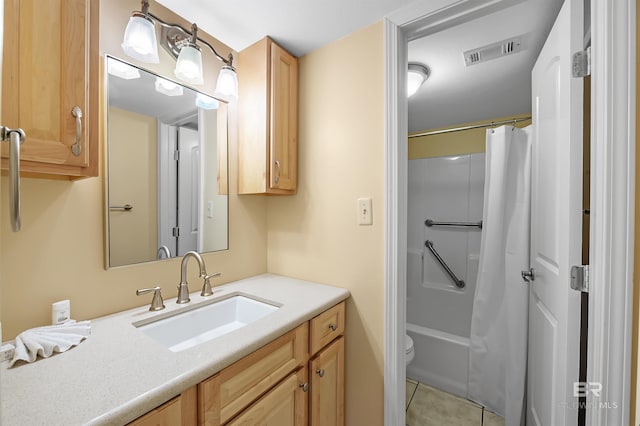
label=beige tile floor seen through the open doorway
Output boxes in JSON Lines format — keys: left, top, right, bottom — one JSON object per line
{"left": 406, "top": 379, "right": 504, "bottom": 426}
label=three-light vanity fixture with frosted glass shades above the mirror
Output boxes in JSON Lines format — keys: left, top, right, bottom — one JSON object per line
{"left": 122, "top": 0, "right": 238, "bottom": 97}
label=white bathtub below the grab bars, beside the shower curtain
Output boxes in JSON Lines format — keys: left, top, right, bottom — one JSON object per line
{"left": 407, "top": 323, "right": 469, "bottom": 398}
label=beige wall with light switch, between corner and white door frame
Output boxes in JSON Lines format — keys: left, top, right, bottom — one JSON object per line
{"left": 268, "top": 23, "right": 384, "bottom": 425}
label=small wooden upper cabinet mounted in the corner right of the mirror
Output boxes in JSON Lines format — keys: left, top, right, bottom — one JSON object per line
{"left": 238, "top": 37, "right": 298, "bottom": 194}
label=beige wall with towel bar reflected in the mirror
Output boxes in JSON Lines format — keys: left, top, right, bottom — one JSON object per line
{"left": 107, "top": 107, "right": 158, "bottom": 266}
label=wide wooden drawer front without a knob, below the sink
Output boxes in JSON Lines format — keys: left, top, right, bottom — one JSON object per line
{"left": 198, "top": 323, "right": 309, "bottom": 425}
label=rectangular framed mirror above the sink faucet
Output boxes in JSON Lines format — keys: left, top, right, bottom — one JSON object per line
{"left": 105, "top": 56, "right": 228, "bottom": 267}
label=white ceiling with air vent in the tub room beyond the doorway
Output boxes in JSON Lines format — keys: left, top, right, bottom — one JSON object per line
{"left": 409, "top": 0, "right": 562, "bottom": 132}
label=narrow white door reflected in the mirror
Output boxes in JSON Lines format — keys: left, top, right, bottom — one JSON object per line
{"left": 178, "top": 127, "right": 200, "bottom": 256}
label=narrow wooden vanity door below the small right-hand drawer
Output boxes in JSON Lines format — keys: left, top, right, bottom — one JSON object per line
{"left": 309, "top": 337, "right": 344, "bottom": 426}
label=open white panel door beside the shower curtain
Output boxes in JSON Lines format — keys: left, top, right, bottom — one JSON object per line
{"left": 527, "top": 0, "right": 583, "bottom": 426}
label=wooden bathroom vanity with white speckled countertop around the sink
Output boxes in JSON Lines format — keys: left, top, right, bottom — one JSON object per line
{"left": 0, "top": 274, "right": 349, "bottom": 425}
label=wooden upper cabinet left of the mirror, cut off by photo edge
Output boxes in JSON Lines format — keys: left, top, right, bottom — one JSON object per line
{"left": 2, "top": 0, "right": 100, "bottom": 178}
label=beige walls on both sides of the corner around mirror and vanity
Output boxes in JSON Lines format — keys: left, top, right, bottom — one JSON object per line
{"left": 0, "top": 0, "right": 384, "bottom": 425}
